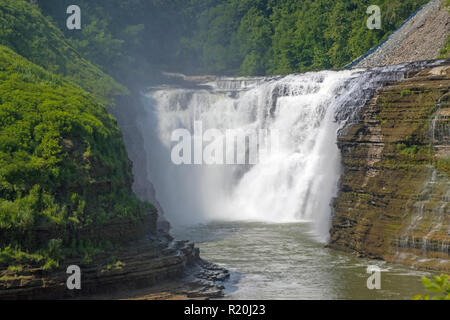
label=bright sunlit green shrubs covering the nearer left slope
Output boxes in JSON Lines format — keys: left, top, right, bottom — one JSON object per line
{"left": 0, "top": 46, "right": 151, "bottom": 269}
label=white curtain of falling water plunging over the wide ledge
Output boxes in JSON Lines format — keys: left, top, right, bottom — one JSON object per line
{"left": 140, "top": 70, "right": 404, "bottom": 241}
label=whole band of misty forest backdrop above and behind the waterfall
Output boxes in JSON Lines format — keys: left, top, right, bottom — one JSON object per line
{"left": 39, "top": 0, "right": 427, "bottom": 77}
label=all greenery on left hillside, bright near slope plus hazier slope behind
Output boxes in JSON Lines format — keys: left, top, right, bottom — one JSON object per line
{"left": 0, "top": 0, "right": 154, "bottom": 268}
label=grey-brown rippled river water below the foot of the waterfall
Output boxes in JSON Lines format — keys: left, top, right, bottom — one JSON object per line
{"left": 173, "top": 222, "right": 431, "bottom": 300}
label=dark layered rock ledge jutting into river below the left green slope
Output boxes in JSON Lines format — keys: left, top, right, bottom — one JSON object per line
{"left": 0, "top": 219, "right": 229, "bottom": 300}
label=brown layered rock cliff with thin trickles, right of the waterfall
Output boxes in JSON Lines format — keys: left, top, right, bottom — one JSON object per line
{"left": 329, "top": 61, "right": 450, "bottom": 272}
